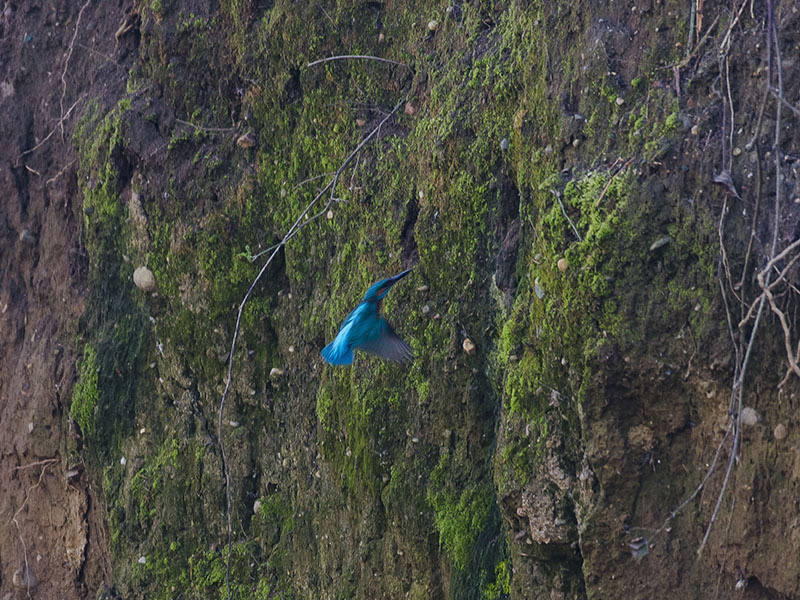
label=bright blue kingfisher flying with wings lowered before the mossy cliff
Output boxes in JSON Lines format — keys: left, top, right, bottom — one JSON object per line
{"left": 322, "top": 269, "right": 414, "bottom": 365}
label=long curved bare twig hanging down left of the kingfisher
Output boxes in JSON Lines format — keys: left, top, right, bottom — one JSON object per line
{"left": 217, "top": 100, "right": 405, "bottom": 599}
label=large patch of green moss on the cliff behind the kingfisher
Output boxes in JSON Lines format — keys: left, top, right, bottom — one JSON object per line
{"left": 70, "top": 0, "right": 711, "bottom": 599}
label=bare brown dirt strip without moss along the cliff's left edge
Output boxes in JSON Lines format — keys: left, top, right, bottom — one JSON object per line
{"left": 0, "top": 0, "right": 137, "bottom": 599}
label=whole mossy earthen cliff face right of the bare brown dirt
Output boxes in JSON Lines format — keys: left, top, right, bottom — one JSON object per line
{"left": 71, "top": 0, "right": 800, "bottom": 599}
